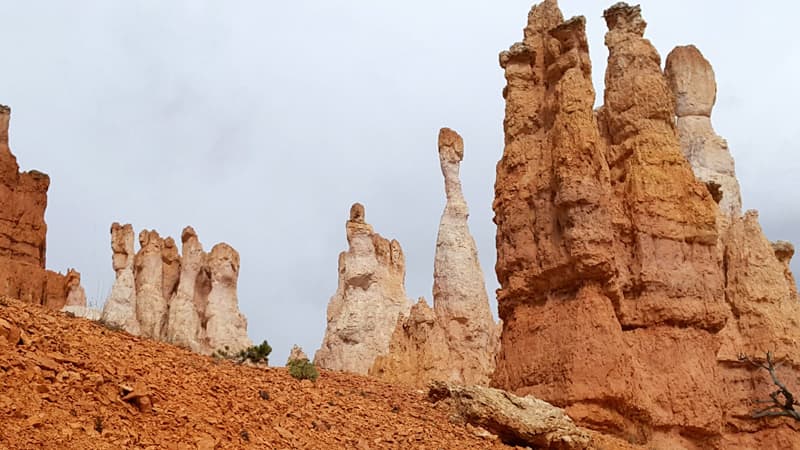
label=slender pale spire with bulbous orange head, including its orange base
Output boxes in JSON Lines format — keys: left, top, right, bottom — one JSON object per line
{"left": 370, "top": 128, "right": 499, "bottom": 386}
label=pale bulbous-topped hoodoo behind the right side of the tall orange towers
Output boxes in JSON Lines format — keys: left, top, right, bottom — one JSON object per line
{"left": 664, "top": 45, "right": 742, "bottom": 218}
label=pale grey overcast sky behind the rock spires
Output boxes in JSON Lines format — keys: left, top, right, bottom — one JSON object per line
{"left": 0, "top": 0, "right": 800, "bottom": 364}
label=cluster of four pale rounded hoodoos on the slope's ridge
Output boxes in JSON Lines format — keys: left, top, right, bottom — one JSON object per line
{"left": 101, "top": 222, "right": 252, "bottom": 354}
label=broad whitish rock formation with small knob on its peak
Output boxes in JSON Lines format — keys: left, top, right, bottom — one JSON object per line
{"left": 314, "top": 203, "right": 411, "bottom": 374}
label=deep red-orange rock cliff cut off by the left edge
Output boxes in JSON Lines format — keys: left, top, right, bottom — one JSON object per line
{"left": 0, "top": 105, "right": 86, "bottom": 309}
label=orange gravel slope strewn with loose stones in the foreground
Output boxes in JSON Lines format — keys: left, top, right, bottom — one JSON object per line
{"left": 0, "top": 298, "right": 509, "bottom": 449}
